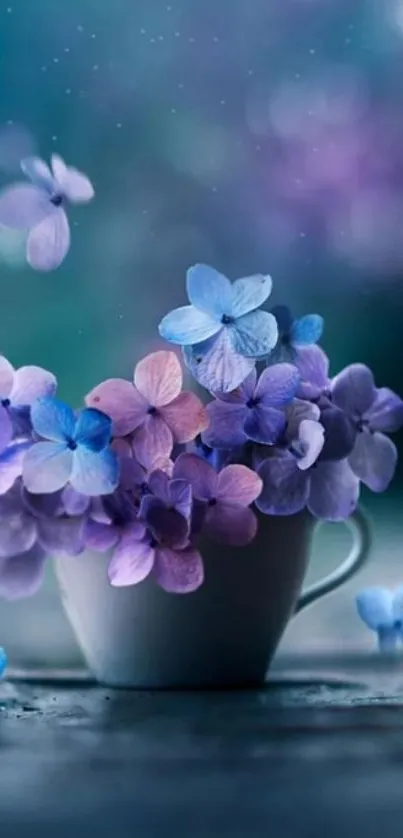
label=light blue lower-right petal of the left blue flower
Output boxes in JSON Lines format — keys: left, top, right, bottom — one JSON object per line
{"left": 70, "top": 447, "right": 119, "bottom": 496}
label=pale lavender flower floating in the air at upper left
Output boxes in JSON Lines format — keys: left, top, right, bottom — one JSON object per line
{"left": 0, "top": 154, "right": 94, "bottom": 271}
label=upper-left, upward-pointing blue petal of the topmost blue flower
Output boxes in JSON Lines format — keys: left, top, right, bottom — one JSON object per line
{"left": 186, "top": 265, "right": 234, "bottom": 321}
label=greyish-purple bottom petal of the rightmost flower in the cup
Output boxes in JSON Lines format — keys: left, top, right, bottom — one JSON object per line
{"left": 348, "top": 433, "right": 397, "bottom": 492}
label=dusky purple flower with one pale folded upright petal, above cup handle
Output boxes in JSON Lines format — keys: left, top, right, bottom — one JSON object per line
{"left": 256, "top": 419, "right": 359, "bottom": 521}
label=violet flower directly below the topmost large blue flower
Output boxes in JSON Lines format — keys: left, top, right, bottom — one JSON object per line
{"left": 202, "top": 364, "right": 300, "bottom": 448}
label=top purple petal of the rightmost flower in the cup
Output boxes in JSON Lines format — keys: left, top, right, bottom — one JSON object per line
{"left": 332, "top": 364, "right": 376, "bottom": 418}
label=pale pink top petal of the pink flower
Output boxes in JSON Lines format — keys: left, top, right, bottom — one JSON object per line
{"left": 134, "top": 351, "right": 182, "bottom": 407}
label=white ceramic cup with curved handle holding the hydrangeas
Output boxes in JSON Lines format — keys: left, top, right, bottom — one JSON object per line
{"left": 56, "top": 510, "right": 371, "bottom": 689}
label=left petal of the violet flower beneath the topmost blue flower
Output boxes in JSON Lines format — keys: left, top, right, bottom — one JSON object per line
{"left": 202, "top": 400, "right": 248, "bottom": 448}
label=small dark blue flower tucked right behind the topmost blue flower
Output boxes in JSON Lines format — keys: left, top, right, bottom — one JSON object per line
{"left": 270, "top": 306, "right": 324, "bottom": 363}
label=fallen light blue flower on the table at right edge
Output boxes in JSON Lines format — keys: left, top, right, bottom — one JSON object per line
{"left": 356, "top": 587, "right": 403, "bottom": 652}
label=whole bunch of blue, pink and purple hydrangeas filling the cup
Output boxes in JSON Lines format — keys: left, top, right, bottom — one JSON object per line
{"left": 0, "top": 265, "right": 403, "bottom": 598}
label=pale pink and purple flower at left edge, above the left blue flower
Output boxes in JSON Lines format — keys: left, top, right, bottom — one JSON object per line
{"left": 0, "top": 356, "right": 57, "bottom": 442}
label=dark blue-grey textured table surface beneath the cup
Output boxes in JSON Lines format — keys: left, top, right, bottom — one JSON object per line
{"left": 0, "top": 657, "right": 403, "bottom": 838}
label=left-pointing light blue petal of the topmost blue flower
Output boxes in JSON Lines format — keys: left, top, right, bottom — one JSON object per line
{"left": 158, "top": 306, "right": 222, "bottom": 346}
